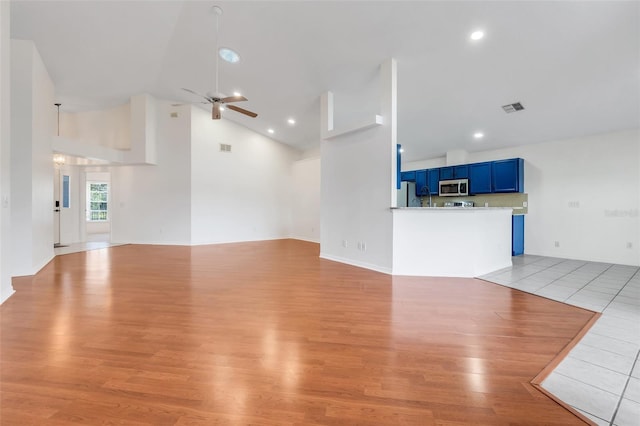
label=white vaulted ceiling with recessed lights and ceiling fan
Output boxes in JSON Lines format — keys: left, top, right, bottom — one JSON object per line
{"left": 11, "top": 0, "right": 640, "bottom": 160}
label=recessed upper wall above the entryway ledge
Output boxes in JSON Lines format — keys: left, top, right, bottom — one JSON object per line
{"left": 60, "top": 103, "right": 131, "bottom": 149}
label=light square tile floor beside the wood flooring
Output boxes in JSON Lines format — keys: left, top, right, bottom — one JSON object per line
{"left": 479, "top": 255, "right": 640, "bottom": 426}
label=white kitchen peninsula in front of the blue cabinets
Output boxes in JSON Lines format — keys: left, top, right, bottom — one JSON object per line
{"left": 391, "top": 207, "right": 513, "bottom": 277}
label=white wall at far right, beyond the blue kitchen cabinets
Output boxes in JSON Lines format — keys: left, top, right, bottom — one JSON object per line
{"left": 403, "top": 129, "right": 640, "bottom": 265}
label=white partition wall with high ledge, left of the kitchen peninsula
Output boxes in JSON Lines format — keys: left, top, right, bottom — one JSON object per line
{"left": 320, "top": 61, "right": 396, "bottom": 273}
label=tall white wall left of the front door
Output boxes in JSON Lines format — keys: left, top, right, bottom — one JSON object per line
{"left": 10, "top": 40, "right": 55, "bottom": 276}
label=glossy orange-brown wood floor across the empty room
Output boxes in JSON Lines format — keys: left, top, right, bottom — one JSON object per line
{"left": 0, "top": 240, "right": 593, "bottom": 425}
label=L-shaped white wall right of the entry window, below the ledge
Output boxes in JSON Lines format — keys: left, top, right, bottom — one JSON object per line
{"left": 109, "top": 100, "right": 191, "bottom": 245}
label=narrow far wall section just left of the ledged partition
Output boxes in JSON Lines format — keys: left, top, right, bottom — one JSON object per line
{"left": 291, "top": 156, "right": 320, "bottom": 243}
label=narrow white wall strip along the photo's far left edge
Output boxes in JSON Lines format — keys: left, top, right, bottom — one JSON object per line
{"left": 0, "top": 0, "right": 13, "bottom": 303}
